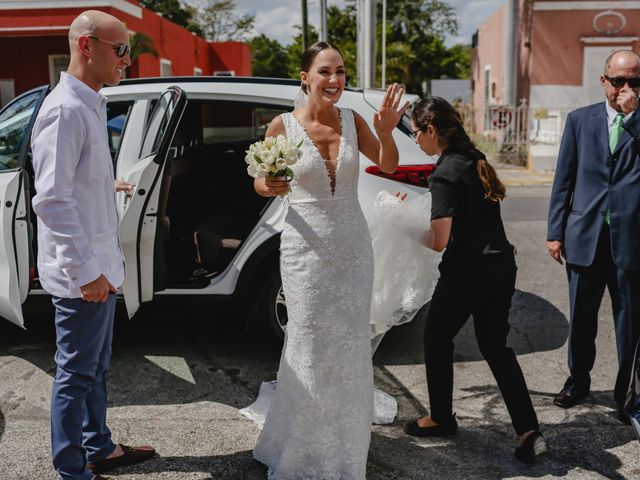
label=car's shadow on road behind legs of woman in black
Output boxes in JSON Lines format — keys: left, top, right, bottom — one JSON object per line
{"left": 374, "top": 290, "right": 569, "bottom": 365}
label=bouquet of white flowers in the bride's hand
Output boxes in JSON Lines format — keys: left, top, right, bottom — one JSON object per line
{"left": 244, "top": 135, "right": 303, "bottom": 193}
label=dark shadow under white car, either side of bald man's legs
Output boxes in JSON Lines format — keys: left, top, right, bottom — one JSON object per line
{"left": 0, "top": 297, "right": 280, "bottom": 408}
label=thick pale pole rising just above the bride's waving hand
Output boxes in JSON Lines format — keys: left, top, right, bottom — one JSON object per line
{"left": 357, "top": 0, "right": 376, "bottom": 88}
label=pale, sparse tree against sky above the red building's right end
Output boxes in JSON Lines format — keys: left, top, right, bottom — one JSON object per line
{"left": 195, "top": 0, "right": 255, "bottom": 42}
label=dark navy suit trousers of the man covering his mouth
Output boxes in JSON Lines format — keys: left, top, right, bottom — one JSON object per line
{"left": 567, "top": 224, "right": 640, "bottom": 410}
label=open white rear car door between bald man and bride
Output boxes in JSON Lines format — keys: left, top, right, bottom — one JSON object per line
{"left": 120, "top": 87, "right": 187, "bottom": 318}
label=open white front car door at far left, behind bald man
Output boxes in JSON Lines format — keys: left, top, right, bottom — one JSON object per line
{"left": 0, "top": 87, "right": 49, "bottom": 328}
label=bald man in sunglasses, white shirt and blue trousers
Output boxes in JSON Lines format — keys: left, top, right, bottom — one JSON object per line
{"left": 31, "top": 10, "right": 155, "bottom": 480}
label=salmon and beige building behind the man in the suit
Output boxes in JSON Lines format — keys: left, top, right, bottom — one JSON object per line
{"left": 472, "top": 0, "right": 640, "bottom": 169}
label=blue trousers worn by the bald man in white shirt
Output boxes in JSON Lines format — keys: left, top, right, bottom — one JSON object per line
{"left": 51, "top": 294, "right": 116, "bottom": 480}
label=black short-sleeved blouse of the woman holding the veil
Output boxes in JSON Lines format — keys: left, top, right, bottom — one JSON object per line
{"left": 429, "top": 147, "right": 513, "bottom": 261}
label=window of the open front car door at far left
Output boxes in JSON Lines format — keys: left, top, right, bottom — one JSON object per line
{"left": 0, "top": 91, "right": 42, "bottom": 170}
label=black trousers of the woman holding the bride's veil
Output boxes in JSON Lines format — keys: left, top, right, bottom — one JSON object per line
{"left": 424, "top": 253, "right": 538, "bottom": 435}
